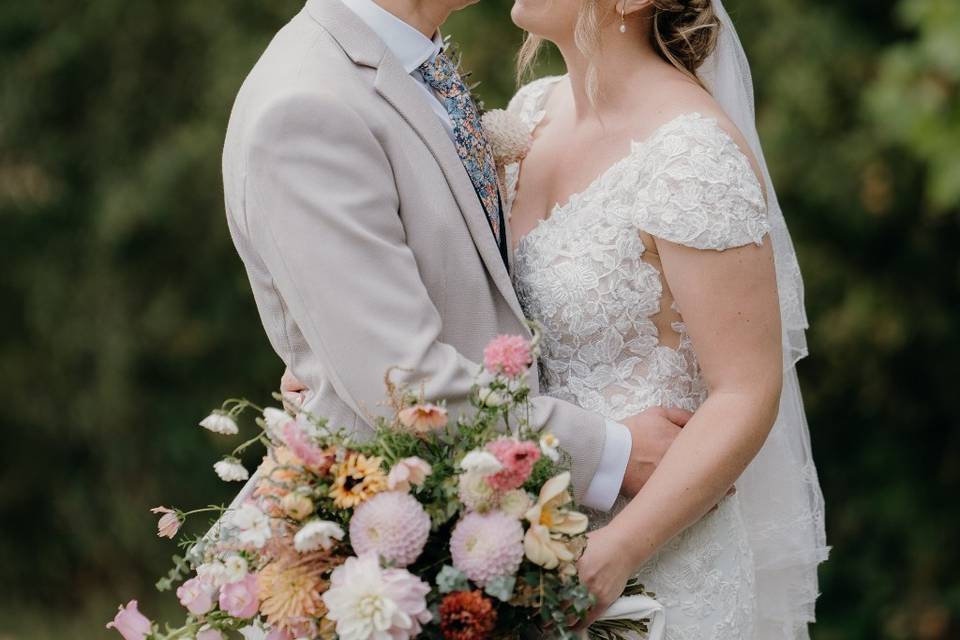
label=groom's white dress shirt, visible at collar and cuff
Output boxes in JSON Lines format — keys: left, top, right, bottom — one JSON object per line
{"left": 342, "top": 0, "right": 633, "bottom": 511}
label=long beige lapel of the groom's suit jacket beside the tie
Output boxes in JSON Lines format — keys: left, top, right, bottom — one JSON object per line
{"left": 307, "top": 0, "right": 524, "bottom": 320}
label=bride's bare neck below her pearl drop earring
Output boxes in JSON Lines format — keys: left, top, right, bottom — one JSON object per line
{"left": 556, "top": 17, "right": 664, "bottom": 120}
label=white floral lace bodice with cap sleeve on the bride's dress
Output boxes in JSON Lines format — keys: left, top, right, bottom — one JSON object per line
{"left": 506, "top": 78, "right": 768, "bottom": 420}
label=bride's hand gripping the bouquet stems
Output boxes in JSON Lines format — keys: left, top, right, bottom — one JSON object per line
{"left": 577, "top": 524, "right": 636, "bottom": 630}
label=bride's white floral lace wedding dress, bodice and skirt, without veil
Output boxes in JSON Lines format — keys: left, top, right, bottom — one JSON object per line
{"left": 506, "top": 78, "right": 772, "bottom": 640}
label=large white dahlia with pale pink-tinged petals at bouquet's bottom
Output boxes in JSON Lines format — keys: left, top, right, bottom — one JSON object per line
{"left": 323, "top": 553, "right": 432, "bottom": 640}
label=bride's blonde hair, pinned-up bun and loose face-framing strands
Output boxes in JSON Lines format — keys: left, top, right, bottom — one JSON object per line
{"left": 517, "top": 0, "right": 720, "bottom": 99}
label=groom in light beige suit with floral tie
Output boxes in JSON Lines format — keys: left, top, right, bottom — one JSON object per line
{"left": 223, "top": 0, "right": 687, "bottom": 510}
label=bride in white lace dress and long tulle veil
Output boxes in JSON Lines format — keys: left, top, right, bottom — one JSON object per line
{"left": 505, "top": 0, "right": 827, "bottom": 640}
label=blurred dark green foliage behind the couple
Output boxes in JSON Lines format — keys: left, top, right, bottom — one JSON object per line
{"left": 0, "top": 0, "right": 960, "bottom": 640}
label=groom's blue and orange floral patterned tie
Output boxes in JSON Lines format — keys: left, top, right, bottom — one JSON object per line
{"left": 418, "top": 52, "right": 503, "bottom": 251}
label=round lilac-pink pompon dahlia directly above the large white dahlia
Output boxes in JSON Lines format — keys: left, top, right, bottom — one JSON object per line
{"left": 350, "top": 491, "right": 430, "bottom": 567}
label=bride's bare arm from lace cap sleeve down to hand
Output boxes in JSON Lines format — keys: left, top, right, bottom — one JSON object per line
{"left": 578, "top": 232, "right": 782, "bottom": 624}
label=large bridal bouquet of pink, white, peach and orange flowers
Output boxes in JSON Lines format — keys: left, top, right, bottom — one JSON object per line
{"left": 107, "top": 336, "right": 646, "bottom": 640}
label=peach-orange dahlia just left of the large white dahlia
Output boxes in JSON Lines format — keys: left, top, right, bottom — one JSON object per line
{"left": 257, "top": 550, "right": 337, "bottom": 629}
